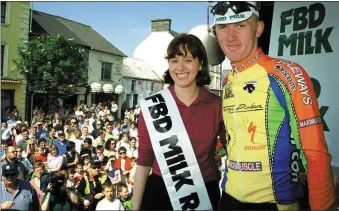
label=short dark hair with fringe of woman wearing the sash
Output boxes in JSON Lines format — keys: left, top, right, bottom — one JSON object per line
{"left": 163, "top": 34, "right": 211, "bottom": 87}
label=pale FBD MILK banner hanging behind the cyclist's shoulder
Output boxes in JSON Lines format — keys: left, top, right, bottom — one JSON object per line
{"left": 269, "top": 2, "right": 339, "bottom": 167}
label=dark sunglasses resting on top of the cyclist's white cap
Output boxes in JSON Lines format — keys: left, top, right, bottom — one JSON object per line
{"left": 211, "top": 1, "right": 260, "bottom": 15}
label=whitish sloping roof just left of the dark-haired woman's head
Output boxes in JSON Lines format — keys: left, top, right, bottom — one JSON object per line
{"left": 121, "top": 58, "right": 161, "bottom": 82}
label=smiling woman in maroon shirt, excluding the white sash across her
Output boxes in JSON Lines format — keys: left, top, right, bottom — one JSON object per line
{"left": 133, "top": 34, "right": 225, "bottom": 210}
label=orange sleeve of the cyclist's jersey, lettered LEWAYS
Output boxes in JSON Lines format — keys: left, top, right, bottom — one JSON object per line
{"left": 282, "top": 62, "right": 335, "bottom": 210}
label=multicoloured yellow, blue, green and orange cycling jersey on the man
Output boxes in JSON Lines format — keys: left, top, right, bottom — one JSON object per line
{"left": 222, "top": 49, "right": 334, "bottom": 210}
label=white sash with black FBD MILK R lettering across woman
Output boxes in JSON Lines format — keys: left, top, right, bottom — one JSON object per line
{"left": 140, "top": 89, "right": 212, "bottom": 210}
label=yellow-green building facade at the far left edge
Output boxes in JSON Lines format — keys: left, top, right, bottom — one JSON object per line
{"left": 1, "top": 1, "right": 30, "bottom": 120}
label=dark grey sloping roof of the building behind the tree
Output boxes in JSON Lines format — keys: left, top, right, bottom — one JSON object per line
{"left": 33, "top": 10, "right": 127, "bottom": 57}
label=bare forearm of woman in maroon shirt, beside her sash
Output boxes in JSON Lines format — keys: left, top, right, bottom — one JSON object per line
{"left": 132, "top": 165, "right": 151, "bottom": 210}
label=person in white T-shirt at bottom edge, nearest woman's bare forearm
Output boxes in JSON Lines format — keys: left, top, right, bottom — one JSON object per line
{"left": 95, "top": 183, "right": 125, "bottom": 211}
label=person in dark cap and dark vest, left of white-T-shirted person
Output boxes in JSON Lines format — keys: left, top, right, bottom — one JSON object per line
{"left": 76, "top": 160, "right": 111, "bottom": 210}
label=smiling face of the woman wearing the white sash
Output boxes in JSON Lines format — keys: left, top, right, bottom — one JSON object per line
{"left": 168, "top": 45, "right": 202, "bottom": 88}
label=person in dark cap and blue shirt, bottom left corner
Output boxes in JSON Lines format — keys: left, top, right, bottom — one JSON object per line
{"left": 0, "top": 163, "right": 39, "bottom": 211}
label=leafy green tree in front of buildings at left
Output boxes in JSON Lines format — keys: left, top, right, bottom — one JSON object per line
{"left": 14, "top": 34, "right": 88, "bottom": 111}
